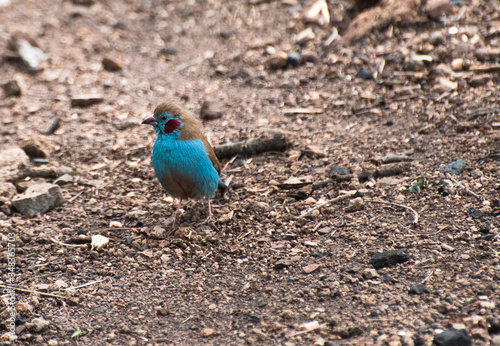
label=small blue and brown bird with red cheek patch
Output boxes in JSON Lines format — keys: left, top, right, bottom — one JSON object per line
{"left": 142, "top": 102, "right": 227, "bottom": 225}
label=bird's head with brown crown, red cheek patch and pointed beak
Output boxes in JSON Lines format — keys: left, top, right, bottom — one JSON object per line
{"left": 142, "top": 103, "right": 184, "bottom": 137}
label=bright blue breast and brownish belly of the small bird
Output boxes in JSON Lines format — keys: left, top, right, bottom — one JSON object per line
{"left": 152, "top": 135, "right": 219, "bottom": 198}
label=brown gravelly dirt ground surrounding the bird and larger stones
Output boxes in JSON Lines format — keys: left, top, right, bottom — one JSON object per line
{"left": 0, "top": 0, "right": 500, "bottom": 345}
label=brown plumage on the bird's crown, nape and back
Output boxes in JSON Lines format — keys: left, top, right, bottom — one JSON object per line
{"left": 154, "top": 102, "right": 221, "bottom": 174}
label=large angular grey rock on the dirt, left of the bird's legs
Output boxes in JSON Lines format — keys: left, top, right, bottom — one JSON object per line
{"left": 12, "top": 183, "right": 65, "bottom": 216}
